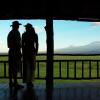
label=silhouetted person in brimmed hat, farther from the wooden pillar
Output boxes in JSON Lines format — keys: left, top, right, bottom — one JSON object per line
{"left": 7, "top": 21, "right": 23, "bottom": 88}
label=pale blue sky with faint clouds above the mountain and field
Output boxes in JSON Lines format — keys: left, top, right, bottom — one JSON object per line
{"left": 0, "top": 20, "right": 100, "bottom": 52}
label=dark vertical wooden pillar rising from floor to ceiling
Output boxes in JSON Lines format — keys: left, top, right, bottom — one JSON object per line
{"left": 45, "top": 18, "right": 54, "bottom": 89}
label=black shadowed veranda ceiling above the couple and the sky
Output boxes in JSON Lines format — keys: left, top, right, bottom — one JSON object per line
{"left": 0, "top": 0, "right": 100, "bottom": 21}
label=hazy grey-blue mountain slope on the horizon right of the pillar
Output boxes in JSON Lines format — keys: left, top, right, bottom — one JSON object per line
{"left": 54, "top": 41, "right": 100, "bottom": 54}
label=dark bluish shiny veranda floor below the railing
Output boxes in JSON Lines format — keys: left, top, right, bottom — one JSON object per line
{"left": 0, "top": 83, "right": 100, "bottom": 100}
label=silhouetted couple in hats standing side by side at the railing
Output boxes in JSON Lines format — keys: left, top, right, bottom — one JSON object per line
{"left": 7, "top": 21, "right": 38, "bottom": 89}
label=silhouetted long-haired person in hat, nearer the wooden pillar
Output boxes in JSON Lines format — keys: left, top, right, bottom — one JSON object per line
{"left": 22, "top": 23, "right": 38, "bottom": 87}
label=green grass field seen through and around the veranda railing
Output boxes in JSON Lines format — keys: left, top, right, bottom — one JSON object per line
{"left": 0, "top": 56, "right": 100, "bottom": 84}
